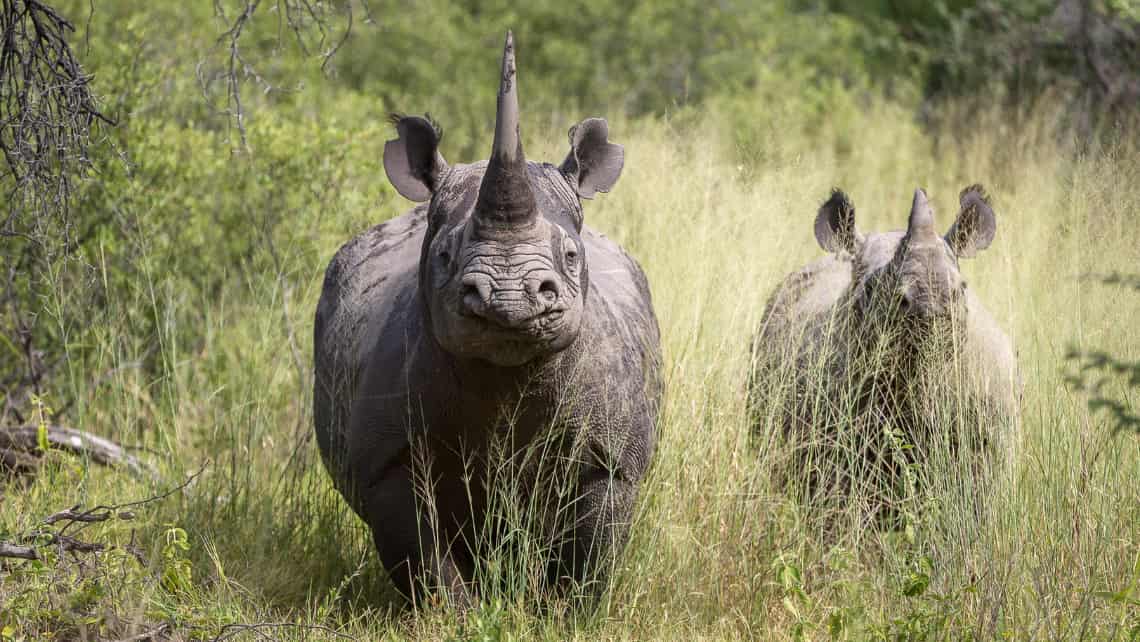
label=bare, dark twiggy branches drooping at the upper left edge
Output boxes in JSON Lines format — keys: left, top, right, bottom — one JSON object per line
{"left": 0, "top": 0, "right": 115, "bottom": 431}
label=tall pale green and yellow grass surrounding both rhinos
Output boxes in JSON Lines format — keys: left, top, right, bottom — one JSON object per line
{"left": 0, "top": 98, "right": 1140, "bottom": 640}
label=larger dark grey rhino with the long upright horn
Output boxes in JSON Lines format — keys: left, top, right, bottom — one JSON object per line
{"left": 315, "top": 33, "right": 661, "bottom": 606}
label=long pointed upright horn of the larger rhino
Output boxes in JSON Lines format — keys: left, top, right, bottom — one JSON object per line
{"left": 475, "top": 31, "right": 538, "bottom": 229}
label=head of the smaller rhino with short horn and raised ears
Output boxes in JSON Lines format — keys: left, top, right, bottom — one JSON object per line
{"left": 815, "top": 185, "right": 996, "bottom": 338}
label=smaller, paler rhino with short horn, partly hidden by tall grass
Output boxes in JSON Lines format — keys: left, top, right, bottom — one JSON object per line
{"left": 749, "top": 185, "right": 1020, "bottom": 514}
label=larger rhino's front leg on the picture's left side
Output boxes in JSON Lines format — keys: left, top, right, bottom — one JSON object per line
{"left": 368, "top": 466, "right": 472, "bottom": 610}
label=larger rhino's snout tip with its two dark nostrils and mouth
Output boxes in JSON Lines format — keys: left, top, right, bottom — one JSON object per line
{"left": 462, "top": 273, "right": 562, "bottom": 330}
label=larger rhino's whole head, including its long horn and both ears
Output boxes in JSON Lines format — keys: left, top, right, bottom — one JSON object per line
{"left": 384, "top": 33, "right": 625, "bottom": 366}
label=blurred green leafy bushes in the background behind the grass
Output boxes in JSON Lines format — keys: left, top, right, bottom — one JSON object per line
{"left": 0, "top": 0, "right": 1140, "bottom": 418}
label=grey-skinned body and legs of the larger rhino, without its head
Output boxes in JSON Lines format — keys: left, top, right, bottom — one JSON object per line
{"left": 315, "top": 171, "right": 661, "bottom": 592}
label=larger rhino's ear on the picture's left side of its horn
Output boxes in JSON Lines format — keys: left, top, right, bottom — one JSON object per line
{"left": 384, "top": 114, "right": 447, "bottom": 203}
